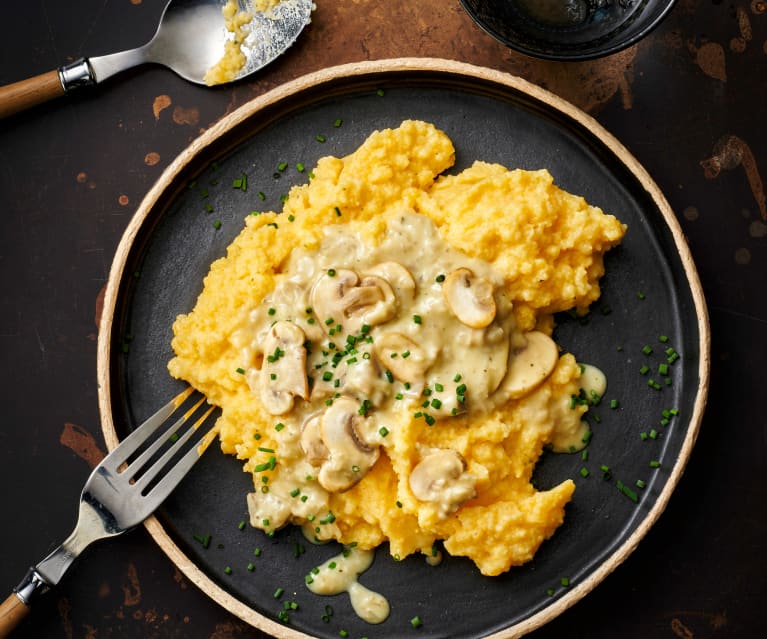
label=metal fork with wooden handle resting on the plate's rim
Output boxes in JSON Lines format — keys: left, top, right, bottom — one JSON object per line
{"left": 0, "top": 388, "right": 215, "bottom": 637}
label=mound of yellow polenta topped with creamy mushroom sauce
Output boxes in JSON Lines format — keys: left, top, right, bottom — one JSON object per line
{"left": 169, "top": 121, "right": 625, "bottom": 575}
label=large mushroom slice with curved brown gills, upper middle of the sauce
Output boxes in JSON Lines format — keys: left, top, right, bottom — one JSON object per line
{"left": 311, "top": 269, "right": 396, "bottom": 334}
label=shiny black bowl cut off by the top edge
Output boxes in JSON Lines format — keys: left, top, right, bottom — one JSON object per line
{"left": 461, "top": 0, "right": 674, "bottom": 60}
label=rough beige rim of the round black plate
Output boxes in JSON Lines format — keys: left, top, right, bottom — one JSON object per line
{"left": 97, "top": 58, "right": 711, "bottom": 639}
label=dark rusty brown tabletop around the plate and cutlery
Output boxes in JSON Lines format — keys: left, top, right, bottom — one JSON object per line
{"left": 0, "top": 0, "right": 767, "bottom": 639}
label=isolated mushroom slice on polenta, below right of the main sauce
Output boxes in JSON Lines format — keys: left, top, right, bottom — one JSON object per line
{"left": 409, "top": 448, "right": 476, "bottom": 517}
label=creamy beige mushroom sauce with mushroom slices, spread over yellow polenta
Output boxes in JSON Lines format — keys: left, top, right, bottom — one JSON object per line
{"left": 233, "top": 213, "right": 604, "bottom": 541}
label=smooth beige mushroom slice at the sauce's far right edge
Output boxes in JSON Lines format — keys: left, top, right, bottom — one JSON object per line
{"left": 498, "top": 331, "right": 559, "bottom": 399}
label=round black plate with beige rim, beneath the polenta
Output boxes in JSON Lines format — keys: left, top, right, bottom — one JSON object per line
{"left": 99, "top": 60, "right": 708, "bottom": 639}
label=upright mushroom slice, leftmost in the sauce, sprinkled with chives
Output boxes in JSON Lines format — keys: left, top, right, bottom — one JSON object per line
{"left": 259, "top": 320, "right": 309, "bottom": 415}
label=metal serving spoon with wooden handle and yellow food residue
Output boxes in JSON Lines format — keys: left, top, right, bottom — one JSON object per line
{"left": 0, "top": 0, "right": 314, "bottom": 118}
